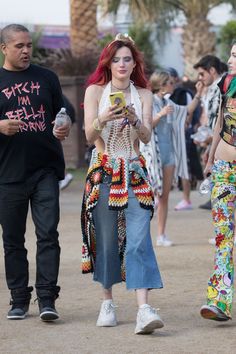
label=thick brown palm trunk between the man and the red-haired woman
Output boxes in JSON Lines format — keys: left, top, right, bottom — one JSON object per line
{"left": 70, "top": 0, "right": 97, "bottom": 58}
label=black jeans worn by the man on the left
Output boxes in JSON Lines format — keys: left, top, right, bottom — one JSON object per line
{"left": 0, "top": 169, "right": 60, "bottom": 293}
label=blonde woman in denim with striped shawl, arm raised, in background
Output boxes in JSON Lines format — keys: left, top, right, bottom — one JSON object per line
{"left": 141, "top": 71, "right": 203, "bottom": 246}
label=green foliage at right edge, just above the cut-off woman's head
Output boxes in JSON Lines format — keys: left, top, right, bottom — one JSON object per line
{"left": 219, "top": 20, "right": 236, "bottom": 61}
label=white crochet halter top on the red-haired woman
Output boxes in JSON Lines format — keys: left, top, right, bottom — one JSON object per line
{"left": 98, "top": 82, "right": 142, "bottom": 159}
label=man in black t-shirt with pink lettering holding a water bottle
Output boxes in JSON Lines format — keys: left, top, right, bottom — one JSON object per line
{"left": 0, "top": 24, "right": 69, "bottom": 321}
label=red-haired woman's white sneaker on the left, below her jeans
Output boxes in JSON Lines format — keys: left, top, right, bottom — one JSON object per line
{"left": 96, "top": 300, "right": 117, "bottom": 327}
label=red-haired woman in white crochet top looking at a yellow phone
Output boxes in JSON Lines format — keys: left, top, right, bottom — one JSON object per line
{"left": 81, "top": 34, "right": 164, "bottom": 334}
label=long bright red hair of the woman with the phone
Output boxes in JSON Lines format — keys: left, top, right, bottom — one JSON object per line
{"left": 87, "top": 40, "right": 147, "bottom": 88}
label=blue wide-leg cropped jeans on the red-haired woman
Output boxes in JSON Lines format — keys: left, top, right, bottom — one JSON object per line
{"left": 93, "top": 183, "right": 163, "bottom": 289}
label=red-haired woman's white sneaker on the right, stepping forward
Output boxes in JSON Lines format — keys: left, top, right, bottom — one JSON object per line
{"left": 134, "top": 304, "right": 164, "bottom": 334}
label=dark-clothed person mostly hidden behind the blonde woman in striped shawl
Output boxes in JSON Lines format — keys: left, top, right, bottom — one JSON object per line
{"left": 166, "top": 67, "right": 203, "bottom": 211}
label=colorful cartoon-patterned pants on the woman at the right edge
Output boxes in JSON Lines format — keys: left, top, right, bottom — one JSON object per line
{"left": 207, "top": 160, "right": 236, "bottom": 318}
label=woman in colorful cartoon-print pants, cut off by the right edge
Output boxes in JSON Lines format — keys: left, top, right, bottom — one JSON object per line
{"left": 200, "top": 42, "right": 236, "bottom": 321}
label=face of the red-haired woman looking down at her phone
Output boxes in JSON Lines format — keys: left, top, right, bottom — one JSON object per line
{"left": 111, "top": 47, "right": 136, "bottom": 80}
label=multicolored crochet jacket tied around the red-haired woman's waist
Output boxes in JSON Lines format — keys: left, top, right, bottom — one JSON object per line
{"left": 81, "top": 153, "right": 154, "bottom": 280}
